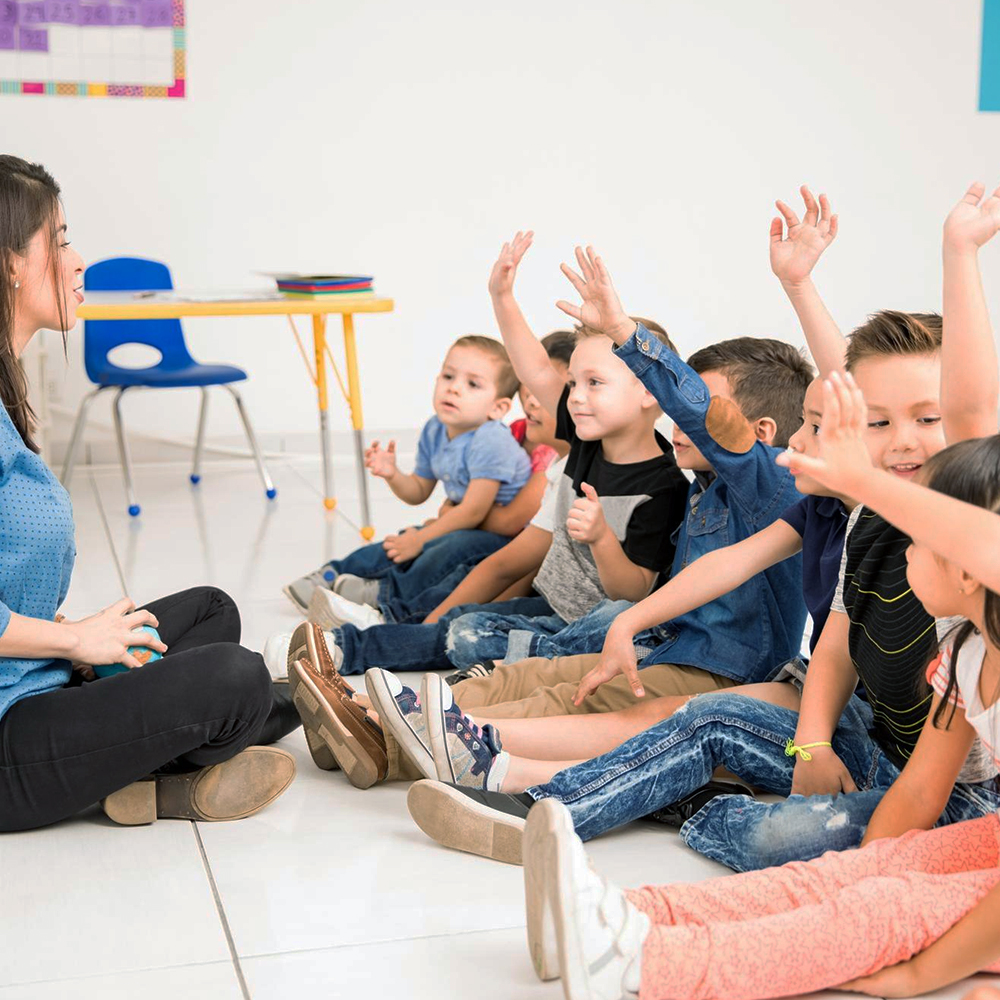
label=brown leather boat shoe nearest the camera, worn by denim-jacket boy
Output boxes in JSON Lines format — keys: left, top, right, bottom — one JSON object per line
{"left": 288, "top": 660, "right": 389, "bottom": 788}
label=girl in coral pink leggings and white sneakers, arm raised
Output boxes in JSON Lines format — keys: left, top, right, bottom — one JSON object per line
{"left": 524, "top": 375, "right": 1000, "bottom": 1000}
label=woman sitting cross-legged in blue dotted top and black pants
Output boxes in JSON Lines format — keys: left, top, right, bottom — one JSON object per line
{"left": 0, "top": 155, "right": 299, "bottom": 831}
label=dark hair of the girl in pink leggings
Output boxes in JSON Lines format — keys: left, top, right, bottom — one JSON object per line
{"left": 923, "top": 434, "right": 1000, "bottom": 729}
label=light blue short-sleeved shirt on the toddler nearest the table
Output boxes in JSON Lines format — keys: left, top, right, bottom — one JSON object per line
{"left": 413, "top": 417, "right": 531, "bottom": 506}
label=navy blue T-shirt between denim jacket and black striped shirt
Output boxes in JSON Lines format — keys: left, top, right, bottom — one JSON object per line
{"left": 781, "top": 496, "right": 849, "bottom": 653}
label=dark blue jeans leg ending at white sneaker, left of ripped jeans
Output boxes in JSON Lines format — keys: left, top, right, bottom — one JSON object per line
{"left": 333, "top": 597, "right": 551, "bottom": 674}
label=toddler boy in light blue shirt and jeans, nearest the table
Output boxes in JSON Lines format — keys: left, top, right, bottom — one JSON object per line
{"left": 285, "top": 336, "right": 531, "bottom": 610}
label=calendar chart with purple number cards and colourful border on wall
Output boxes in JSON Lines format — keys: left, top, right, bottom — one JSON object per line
{"left": 0, "top": 0, "right": 187, "bottom": 97}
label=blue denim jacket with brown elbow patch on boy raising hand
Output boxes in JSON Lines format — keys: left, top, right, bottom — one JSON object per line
{"left": 615, "top": 323, "right": 806, "bottom": 683}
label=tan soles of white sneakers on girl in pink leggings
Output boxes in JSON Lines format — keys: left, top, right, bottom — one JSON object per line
{"left": 524, "top": 799, "right": 576, "bottom": 984}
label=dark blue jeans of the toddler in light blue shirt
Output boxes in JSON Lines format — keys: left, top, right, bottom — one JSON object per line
{"left": 324, "top": 528, "right": 510, "bottom": 622}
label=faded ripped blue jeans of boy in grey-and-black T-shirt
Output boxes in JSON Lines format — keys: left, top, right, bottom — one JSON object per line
{"left": 448, "top": 600, "right": 667, "bottom": 670}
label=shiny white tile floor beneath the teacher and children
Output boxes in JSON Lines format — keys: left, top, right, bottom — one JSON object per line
{"left": 0, "top": 458, "right": 988, "bottom": 1000}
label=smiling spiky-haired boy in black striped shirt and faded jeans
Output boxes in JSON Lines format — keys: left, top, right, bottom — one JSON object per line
{"left": 402, "top": 185, "right": 1000, "bottom": 870}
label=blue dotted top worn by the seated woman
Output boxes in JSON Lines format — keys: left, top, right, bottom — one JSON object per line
{"left": 0, "top": 406, "right": 76, "bottom": 717}
